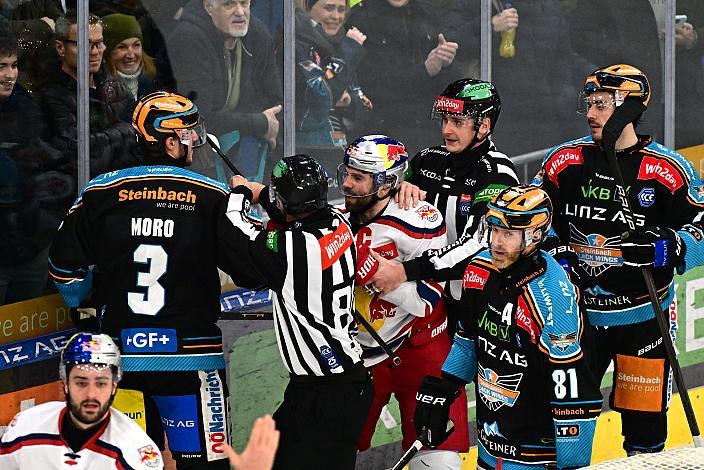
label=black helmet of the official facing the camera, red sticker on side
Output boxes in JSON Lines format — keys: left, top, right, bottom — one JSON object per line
{"left": 431, "top": 78, "right": 501, "bottom": 132}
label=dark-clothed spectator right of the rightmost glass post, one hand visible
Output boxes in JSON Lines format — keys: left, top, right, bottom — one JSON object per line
{"left": 675, "top": 0, "right": 704, "bottom": 148}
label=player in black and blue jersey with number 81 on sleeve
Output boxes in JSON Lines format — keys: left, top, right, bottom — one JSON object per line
{"left": 414, "top": 186, "right": 602, "bottom": 470}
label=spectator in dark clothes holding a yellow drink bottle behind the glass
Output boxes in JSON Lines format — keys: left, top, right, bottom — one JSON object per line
{"left": 443, "top": 0, "right": 595, "bottom": 156}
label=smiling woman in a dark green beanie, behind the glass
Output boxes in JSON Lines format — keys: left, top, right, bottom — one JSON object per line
{"left": 102, "top": 13, "right": 163, "bottom": 101}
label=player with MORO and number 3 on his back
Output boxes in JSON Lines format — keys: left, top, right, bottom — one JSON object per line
{"left": 49, "top": 92, "right": 252, "bottom": 470}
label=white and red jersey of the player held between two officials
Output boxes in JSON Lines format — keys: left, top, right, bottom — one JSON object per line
{"left": 346, "top": 200, "right": 447, "bottom": 367}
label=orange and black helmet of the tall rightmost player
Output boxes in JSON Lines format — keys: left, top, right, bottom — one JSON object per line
{"left": 582, "top": 64, "right": 650, "bottom": 107}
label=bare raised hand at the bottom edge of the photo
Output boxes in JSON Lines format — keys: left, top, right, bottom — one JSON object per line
{"left": 223, "top": 415, "right": 279, "bottom": 470}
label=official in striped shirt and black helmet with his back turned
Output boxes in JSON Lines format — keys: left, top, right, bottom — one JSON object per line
{"left": 220, "top": 155, "right": 374, "bottom": 469}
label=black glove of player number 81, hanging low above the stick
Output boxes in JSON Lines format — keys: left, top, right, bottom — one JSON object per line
{"left": 413, "top": 375, "right": 460, "bottom": 448}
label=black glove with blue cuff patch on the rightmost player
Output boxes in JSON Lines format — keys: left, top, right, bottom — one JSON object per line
{"left": 621, "top": 227, "right": 687, "bottom": 268}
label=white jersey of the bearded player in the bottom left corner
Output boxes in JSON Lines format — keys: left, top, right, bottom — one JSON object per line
{"left": 0, "top": 401, "right": 164, "bottom": 470}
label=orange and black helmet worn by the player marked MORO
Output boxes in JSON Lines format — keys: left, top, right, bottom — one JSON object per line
{"left": 132, "top": 91, "right": 206, "bottom": 147}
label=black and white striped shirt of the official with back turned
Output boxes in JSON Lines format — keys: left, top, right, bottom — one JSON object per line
{"left": 218, "top": 187, "right": 361, "bottom": 376}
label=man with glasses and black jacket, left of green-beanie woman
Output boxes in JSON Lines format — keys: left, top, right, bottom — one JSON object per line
{"left": 40, "top": 10, "right": 136, "bottom": 175}
